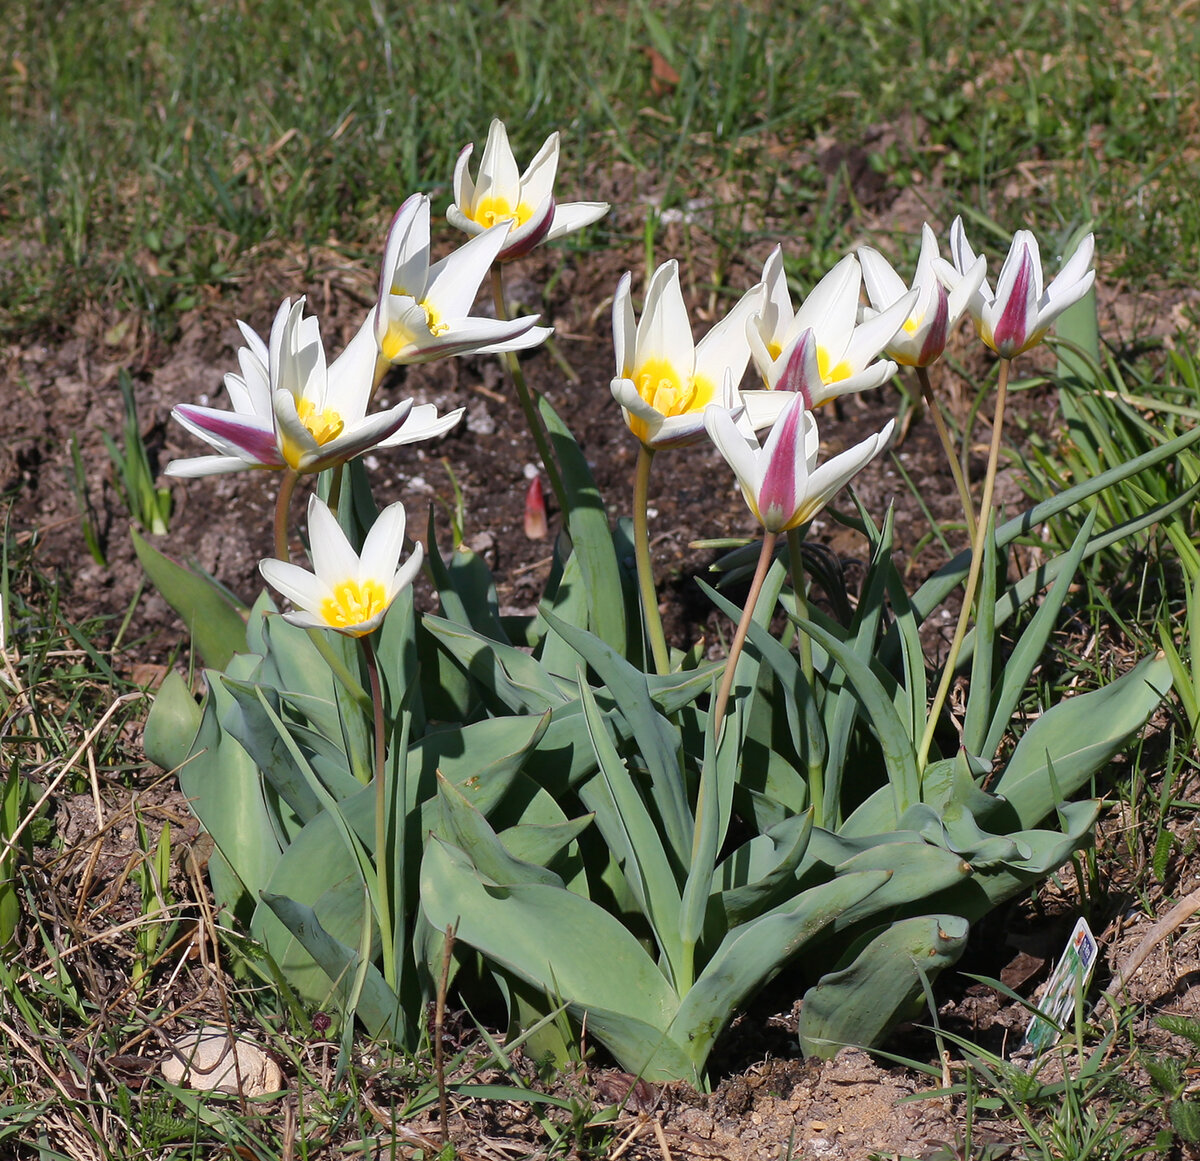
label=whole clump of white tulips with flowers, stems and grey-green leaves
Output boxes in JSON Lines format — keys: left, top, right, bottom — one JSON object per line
{"left": 139, "top": 122, "right": 1193, "bottom": 1084}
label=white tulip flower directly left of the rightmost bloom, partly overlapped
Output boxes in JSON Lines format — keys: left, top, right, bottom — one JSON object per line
{"left": 858, "top": 222, "right": 988, "bottom": 367}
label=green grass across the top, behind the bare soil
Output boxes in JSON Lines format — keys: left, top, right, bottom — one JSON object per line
{"left": 7, "top": 0, "right": 1200, "bottom": 332}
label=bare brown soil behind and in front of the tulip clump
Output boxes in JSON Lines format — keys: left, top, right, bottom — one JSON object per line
{"left": 0, "top": 167, "right": 1200, "bottom": 1161}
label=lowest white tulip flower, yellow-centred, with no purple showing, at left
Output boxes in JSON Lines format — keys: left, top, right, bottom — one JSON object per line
{"left": 258, "top": 495, "right": 424, "bottom": 637}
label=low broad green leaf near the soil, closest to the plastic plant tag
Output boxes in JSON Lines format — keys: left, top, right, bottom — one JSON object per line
{"left": 800, "top": 915, "right": 970, "bottom": 1059}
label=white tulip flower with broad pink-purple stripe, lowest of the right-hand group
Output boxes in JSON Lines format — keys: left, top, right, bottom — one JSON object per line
{"left": 704, "top": 393, "right": 893, "bottom": 533}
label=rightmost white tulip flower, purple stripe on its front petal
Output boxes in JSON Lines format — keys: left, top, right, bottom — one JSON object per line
{"left": 935, "top": 217, "right": 1096, "bottom": 359}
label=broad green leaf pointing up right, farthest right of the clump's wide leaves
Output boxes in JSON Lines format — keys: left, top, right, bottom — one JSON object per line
{"left": 992, "top": 654, "right": 1171, "bottom": 826}
